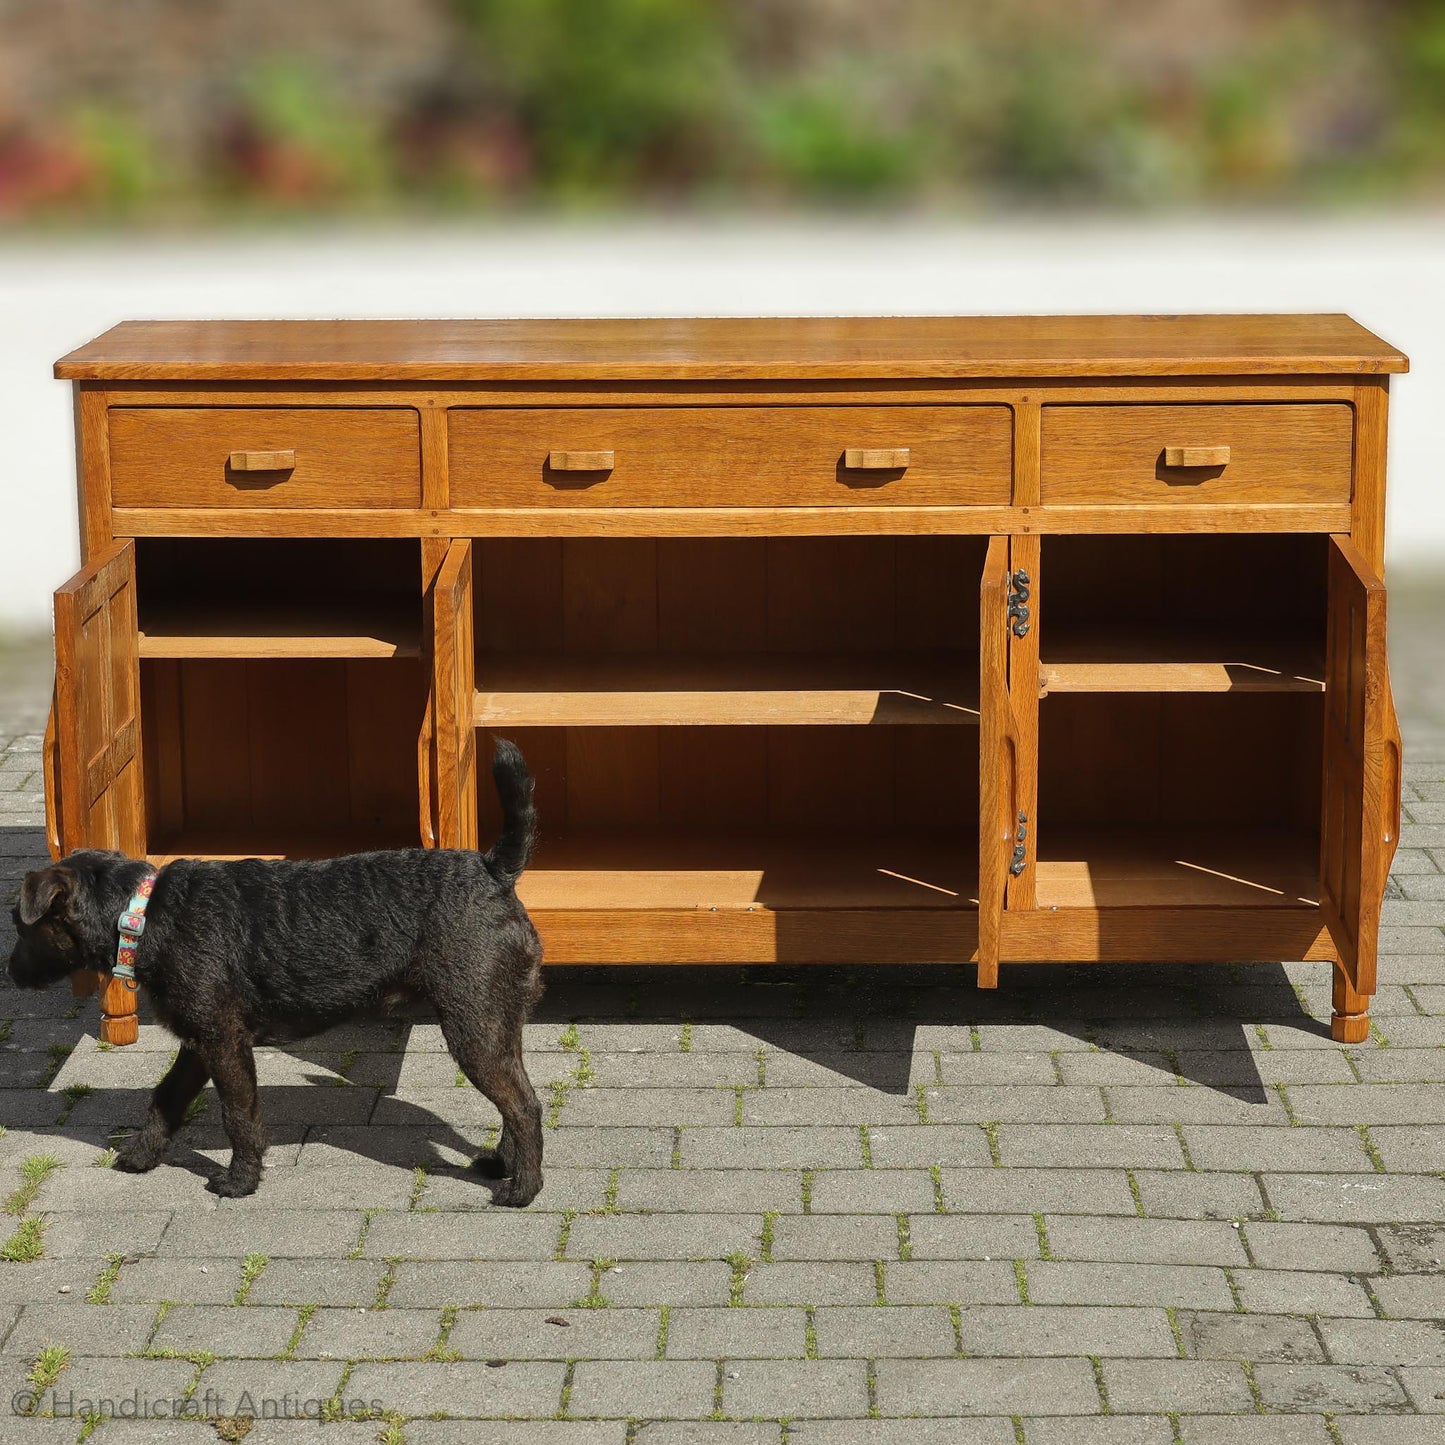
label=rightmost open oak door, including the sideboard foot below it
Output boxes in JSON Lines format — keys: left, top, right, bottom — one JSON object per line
{"left": 1319, "top": 536, "right": 1400, "bottom": 1043}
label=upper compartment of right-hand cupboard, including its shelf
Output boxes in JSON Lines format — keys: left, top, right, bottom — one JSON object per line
{"left": 1039, "top": 535, "right": 1329, "bottom": 694}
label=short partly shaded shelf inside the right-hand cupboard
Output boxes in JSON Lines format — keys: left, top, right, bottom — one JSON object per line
{"left": 1039, "top": 633, "right": 1325, "bottom": 692}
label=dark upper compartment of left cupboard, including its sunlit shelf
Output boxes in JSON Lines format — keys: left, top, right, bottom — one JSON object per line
{"left": 136, "top": 538, "right": 422, "bottom": 659}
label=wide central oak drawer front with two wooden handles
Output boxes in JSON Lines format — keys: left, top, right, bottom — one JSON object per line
{"left": 449, "top": 406, "right": 1013, "bottom": 507}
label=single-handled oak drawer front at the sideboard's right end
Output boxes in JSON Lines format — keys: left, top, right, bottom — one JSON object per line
{"left": 1040, "top": 402, "right": 1354, "bottom": 506}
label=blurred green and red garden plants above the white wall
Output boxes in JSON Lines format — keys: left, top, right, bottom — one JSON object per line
{"left": 0, "top": 0, "right": 1445, "bottom": 227}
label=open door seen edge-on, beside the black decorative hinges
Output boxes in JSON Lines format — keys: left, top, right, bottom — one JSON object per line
{"left": 978, "top": 538, "right": 1019, "bottom": 988}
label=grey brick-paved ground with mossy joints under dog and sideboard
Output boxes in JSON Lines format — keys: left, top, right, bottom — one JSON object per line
{"left": 0, "top": 590, "right": 1445, "bottom": 1445}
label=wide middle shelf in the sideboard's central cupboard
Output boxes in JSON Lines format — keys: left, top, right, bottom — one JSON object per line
{"left": 474, "top": 652, "right": 978, "bottom": 727}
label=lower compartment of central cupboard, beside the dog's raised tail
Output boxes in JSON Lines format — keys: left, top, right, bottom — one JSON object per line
{"left": 478, "top": 725, "right": 978, "bottom": 912}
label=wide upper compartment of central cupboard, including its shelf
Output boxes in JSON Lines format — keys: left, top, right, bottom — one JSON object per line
{"left": 474, "top": 536, "right": 985, "bottom": 728}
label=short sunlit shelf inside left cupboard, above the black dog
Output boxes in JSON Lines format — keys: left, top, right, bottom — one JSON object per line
{"left": 140, "top": 604, "right": 420, "bottom": 657}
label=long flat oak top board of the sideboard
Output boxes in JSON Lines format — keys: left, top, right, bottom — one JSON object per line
{"left": 55, "top": 315, "right": 1409, "bottom": 381}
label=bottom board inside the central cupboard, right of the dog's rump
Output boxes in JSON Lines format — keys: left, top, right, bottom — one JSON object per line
{"left": 517, "top": 821, "right": 978, "bottom": 913}
